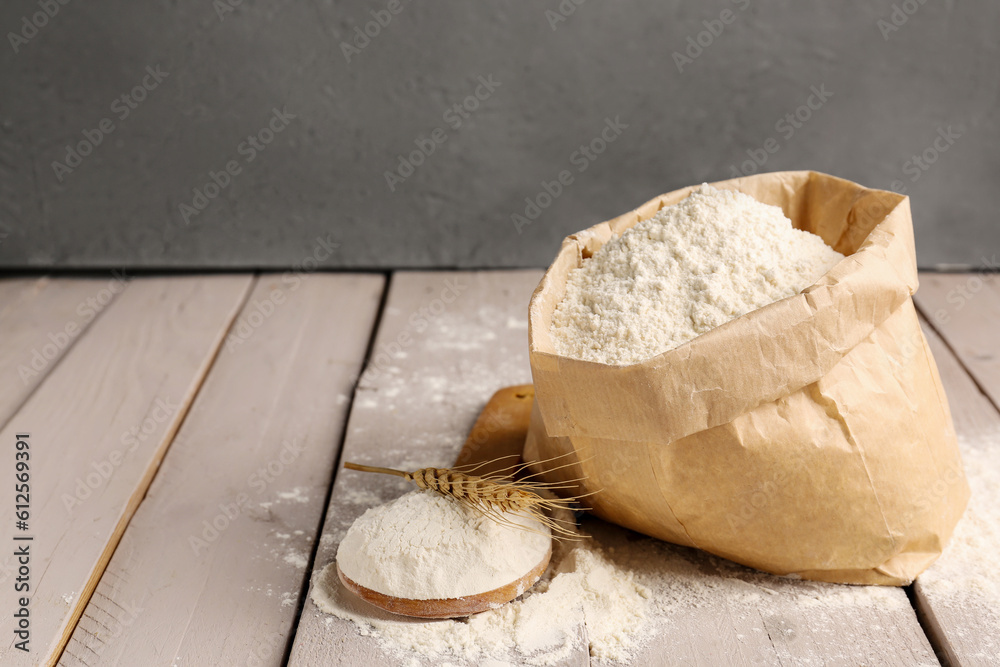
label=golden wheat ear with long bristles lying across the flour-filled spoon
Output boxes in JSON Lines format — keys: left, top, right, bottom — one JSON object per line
{"left": 344, "top": 457, "right": 597, "bottom": 540}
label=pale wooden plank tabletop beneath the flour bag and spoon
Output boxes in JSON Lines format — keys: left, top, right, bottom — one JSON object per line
{"left": 0, "top": 271, "right": 1000, "bottom": 667}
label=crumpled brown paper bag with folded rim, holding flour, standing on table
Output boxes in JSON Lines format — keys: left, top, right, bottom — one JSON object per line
{"left": 524, "top": 171, "right": 969, "bottom": 585}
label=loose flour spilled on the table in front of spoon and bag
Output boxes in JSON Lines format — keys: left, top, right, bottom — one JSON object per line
{"left": 311, "top": 518, "right": 920, "bottom": 667}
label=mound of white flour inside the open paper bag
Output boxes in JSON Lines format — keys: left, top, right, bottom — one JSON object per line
{"left": 551, "top": 185, "right": 843, "bottom": 364}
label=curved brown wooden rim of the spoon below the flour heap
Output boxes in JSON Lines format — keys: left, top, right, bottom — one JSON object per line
{"left": 337, "top": 546, "right": 552, "bottom": 618}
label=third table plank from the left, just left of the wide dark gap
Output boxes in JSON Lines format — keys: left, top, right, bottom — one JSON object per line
{"left": 60, "top": 274, "right": 384, "bottom": 665}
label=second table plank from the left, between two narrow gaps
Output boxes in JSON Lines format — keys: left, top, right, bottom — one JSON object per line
{"left": 0, "top": 276, "right": 252, "bottom": 665}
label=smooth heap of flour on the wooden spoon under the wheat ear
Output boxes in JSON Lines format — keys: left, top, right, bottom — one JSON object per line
{"left": 337, "top": 490, "right": 552, "bottom": 600}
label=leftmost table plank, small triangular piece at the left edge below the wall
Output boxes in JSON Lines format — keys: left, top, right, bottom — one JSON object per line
{"left": 0, "top": 277, "right": 126, "bottom": 428}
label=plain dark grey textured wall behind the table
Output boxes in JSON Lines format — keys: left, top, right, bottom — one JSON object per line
{"left": 0, "top": 0, "right": 1000, "bottom": 268}
